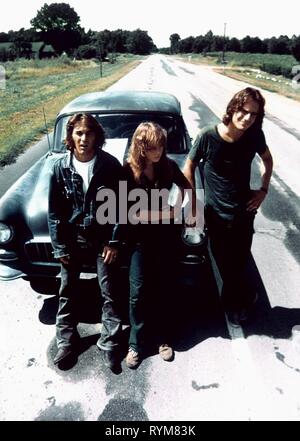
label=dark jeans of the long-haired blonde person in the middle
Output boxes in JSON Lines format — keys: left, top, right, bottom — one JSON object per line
{"left": 129, "top": 226, "right": 178, "bottom": 352}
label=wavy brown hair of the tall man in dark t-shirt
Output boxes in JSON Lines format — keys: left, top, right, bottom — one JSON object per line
{"left": 222, "top": 87, "right": 265, "bottom": 128}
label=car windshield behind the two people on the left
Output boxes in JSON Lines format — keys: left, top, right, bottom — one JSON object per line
{"left": 53, "top": 113, "right": 187, "bottom": 153}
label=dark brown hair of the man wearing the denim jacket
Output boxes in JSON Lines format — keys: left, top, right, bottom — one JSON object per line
{"left": 64, "top": 113, "right": 105, "bottom": 152}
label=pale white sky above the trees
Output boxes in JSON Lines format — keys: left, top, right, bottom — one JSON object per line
{"left": 0, "top": 0, "right": 300, "bottom": 47}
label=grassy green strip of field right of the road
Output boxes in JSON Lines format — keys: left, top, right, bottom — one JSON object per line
{"left": 180, "top": 52, "right": 300, "bottom": 101}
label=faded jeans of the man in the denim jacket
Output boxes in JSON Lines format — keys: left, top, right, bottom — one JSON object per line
{"left": 56, "top": 249, "right": 122, "bottom": 350}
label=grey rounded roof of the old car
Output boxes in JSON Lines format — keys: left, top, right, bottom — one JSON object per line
{"left": 58, "top": 90, "right": 181, "bottom": 117}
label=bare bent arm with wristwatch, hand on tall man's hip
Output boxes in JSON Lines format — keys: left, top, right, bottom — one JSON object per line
{"left": 247, "top": 148, "right": 273, "bottom": 211}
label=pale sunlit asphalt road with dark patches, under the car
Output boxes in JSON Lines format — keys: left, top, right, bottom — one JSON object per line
{"left": 0, "top": 55, "right": 300, "bottom": 422}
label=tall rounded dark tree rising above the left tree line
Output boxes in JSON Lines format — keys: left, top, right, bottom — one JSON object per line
{"left": 31, "top": 3, "right": 82, "bottom": 54}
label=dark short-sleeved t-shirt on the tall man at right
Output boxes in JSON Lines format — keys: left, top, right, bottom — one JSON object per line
{"left": 189, "top": 126, "right": 267, "bottom": 219}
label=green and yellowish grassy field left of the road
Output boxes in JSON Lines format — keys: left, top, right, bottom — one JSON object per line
{"left": 0, "top": 55, "right": 141, "bottom": 166}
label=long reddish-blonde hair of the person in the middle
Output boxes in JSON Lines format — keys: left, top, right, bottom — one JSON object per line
{"left": 127, "top": 122, "right": 171, "bottom": 183}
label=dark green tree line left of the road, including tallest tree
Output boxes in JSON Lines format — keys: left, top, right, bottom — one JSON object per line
{"left": 0, "top": 3, "right": 157, "bottom": 61}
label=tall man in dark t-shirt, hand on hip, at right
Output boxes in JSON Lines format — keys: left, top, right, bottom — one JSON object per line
{"left": 184, "top": 87, "right": 273, "bottom": 325}
